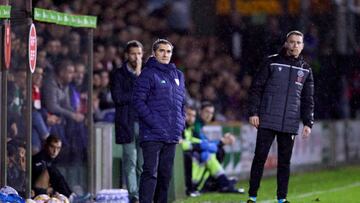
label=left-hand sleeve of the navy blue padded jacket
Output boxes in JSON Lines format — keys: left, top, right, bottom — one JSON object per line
{"left": 132, "top": 71, "right": 162, "bottom": 129}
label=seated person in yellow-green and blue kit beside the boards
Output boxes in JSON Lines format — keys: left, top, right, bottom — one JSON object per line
{"left": 181, "top": 104, "right": 244, "bottom": 197}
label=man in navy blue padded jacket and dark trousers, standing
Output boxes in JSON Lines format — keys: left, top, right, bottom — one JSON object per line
{"left": 133, "top": 39, "right": 185, "bottom": 203}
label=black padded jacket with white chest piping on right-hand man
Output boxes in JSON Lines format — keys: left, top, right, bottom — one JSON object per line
{"left": 249, "top": 50, "right": 314, "bottom": 134}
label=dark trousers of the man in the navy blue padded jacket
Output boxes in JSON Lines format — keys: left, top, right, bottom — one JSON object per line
{"left": 139, "top": 142, "right": 176, "bottom": 203}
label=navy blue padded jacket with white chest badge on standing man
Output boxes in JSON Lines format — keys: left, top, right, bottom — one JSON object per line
{"left": 133, "top": 57, "right": 185, "bottom": 143}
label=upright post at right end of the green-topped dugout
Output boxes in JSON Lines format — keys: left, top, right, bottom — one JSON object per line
{"left": 87, "top": 29, "right": 96, "bottom": 194}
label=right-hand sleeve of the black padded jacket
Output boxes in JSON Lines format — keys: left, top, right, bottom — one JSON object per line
{"left": 300, "top": 69, "right": 314, "bottom": 128}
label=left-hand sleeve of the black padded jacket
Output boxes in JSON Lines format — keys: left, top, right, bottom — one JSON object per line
{"left": 248, "top": 61, "right": 270, "bottom": 116}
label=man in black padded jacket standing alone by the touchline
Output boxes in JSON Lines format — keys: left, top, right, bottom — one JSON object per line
{"left": 247, "top": 31, "right": 314, "bottom": 203}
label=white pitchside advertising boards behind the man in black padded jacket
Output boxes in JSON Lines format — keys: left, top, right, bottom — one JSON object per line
{"left": 204, "top": 120, "right": 360, "bottom": 176}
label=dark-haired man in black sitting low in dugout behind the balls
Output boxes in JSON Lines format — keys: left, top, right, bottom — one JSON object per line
{"left": 32, "top": 134, "right": 72, "bottom": 197}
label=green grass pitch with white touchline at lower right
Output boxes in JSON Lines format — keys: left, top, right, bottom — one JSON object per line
{"left": 176, "top": 165, "right": 360, "bottom": 203}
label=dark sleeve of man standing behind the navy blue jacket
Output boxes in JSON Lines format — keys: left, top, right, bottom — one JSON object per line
{"left": 110, "top": 69, "right": 132, "bottom": 106}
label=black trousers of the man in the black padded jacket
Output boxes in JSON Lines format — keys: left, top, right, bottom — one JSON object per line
{"left": 249, "top": 128, "right": 294, "bottom": 199}
